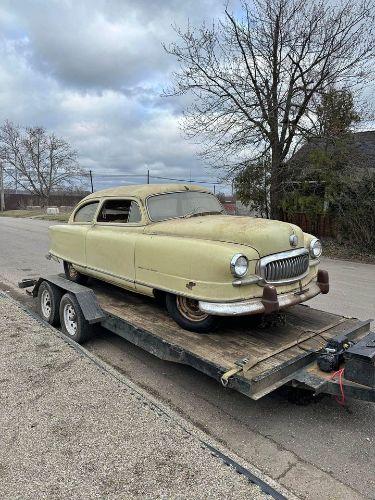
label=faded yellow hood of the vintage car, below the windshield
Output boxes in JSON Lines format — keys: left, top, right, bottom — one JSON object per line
{"left": 145, "top": 215, "right": 304, "bottom": 257}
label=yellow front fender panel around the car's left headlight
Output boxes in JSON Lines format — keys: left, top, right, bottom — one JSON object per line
{"left": 135, "top": 234, "right": 261, "bottom": 301}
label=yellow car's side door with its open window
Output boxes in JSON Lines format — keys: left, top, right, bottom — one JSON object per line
{"left": 86, "top": 198, "right": 144, "bottom": 288}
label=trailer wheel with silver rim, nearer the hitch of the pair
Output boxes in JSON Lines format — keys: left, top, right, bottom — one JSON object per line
{"left": 60, "top": 293, "right": 93, "bottom": 344}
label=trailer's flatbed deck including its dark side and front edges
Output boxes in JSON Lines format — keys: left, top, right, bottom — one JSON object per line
{"left": 90, "top": 280, "right": 370, "bottom": 399}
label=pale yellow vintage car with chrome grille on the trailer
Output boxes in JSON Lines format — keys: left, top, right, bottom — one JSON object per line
{"left": 50, "top": 184, "right": 329, "bottom": 332}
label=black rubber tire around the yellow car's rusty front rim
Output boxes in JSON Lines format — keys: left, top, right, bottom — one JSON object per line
{"left": 166, "top": 294, "right": 219, "bottom": 333}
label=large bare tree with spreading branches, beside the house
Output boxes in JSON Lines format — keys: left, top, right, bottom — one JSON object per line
{"left": 165, "top": 0, "right": 375, "bottom": 218}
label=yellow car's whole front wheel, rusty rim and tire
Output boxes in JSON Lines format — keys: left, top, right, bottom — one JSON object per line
{"left": 166, "top": 294, "right": 218, "bottom": 333}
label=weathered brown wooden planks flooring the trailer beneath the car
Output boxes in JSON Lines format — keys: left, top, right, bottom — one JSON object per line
{"left": 89, "top": 282, "right": 368, "bottom": 379}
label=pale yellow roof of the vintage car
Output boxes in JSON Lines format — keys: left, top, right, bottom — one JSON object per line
{"left": 85, "top": 184, "right": 210, "bottom": 200}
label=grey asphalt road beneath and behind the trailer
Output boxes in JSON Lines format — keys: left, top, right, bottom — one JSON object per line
{"left": 0, "top": 218, "right": 375, "bottom": 499}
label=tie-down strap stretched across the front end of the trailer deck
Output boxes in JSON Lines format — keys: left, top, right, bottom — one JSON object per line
{"left": 220, "top": 317, "right": 347, "bottom": 387}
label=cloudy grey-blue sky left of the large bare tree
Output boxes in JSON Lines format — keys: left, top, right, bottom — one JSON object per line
{"left": 0, "top": 0, "right": 232, "bottom": 188}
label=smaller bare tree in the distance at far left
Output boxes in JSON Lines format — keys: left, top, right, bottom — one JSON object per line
{"left": 0, "top": 121, "right": 85, "bottom": 205}
